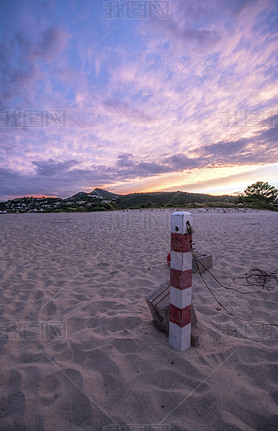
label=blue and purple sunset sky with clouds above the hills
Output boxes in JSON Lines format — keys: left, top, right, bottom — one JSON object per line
{"left": 0, "top": 0, "right": 278, "bottom": 200}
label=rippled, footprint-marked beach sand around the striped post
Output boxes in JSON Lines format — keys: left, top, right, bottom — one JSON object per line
{"left": 0, "top": 209, "right": 278, "bottom": 431}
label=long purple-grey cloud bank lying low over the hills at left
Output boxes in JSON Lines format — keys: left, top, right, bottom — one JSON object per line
{"left": 0, "top": 153, "right": 200, "bottom": 197}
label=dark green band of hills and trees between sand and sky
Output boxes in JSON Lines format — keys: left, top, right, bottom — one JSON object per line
{"left": 0, "top": 181, "right": 278, "bottom": 213}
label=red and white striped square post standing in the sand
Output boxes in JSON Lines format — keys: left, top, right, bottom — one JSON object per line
{"left": 169, "top": 211, "right": 192, "bottom": 351}
